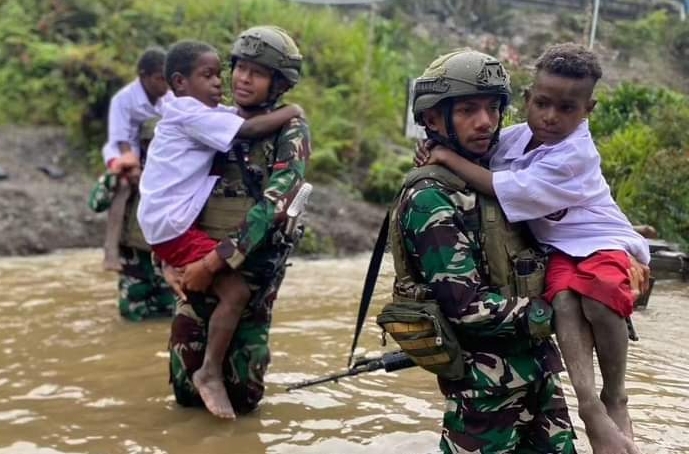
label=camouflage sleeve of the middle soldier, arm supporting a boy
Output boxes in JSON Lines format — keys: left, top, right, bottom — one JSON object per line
{"left": 216, "top": 118, "right": 311, "bottom": 269}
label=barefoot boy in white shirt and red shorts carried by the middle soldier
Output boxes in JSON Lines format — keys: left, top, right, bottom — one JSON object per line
{"left": 137, "top": 41, "right": 302, "bottom": 419}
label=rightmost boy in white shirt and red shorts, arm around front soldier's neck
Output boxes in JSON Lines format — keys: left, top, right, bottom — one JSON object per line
{"left": 416, "top": 43, "right": 650, "bottom": 453}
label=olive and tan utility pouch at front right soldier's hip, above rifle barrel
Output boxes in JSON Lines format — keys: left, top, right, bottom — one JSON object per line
{"left": 376, "top": 298, "right": 464, "bottom": 380}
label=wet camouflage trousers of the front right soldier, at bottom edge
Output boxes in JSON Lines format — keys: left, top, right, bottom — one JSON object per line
{"left": 440, "top": 375, "right": 576, "bottom": 454}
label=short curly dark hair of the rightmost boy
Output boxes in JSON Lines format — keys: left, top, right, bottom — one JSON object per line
{"left": 536, "top": 43, "right": 603, "bottom": 83}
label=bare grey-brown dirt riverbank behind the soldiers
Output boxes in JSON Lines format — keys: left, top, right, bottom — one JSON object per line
{"left": 0, "top": 126, "right": 385, "bottom": 256}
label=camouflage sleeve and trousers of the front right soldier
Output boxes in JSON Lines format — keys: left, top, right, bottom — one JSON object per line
{"left": 394, "top": 176, "right": 574, "bottom": 454}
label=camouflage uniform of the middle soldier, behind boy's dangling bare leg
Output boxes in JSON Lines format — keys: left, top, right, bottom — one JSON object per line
{"left": 169, "top": 114, "right": 311, "bottom": 413}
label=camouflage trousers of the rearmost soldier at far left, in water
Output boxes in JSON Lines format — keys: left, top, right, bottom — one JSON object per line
{"left": 117, "top": 246, "right": 175, "bottom": 321}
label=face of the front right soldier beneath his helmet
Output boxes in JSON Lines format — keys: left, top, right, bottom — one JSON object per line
{"left": 426, "top": 95, "right": 500, "bottom": 154}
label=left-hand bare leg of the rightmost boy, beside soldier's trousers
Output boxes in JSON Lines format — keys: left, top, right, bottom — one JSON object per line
{"left": 553, "top": 291, "right": 638, "bottom": 454}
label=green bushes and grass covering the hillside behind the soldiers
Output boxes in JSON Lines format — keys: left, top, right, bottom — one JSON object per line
{"left": 0, "top": 0, "right": 689, "bottom": 243}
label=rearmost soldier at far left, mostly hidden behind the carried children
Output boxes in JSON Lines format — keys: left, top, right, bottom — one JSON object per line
{"left": 88, "top": 118, "right": 175, "bottom": 321}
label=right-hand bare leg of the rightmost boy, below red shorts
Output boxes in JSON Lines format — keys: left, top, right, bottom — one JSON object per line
{"left": 582, "top": 297, "right": 633, "bottom": 438}
